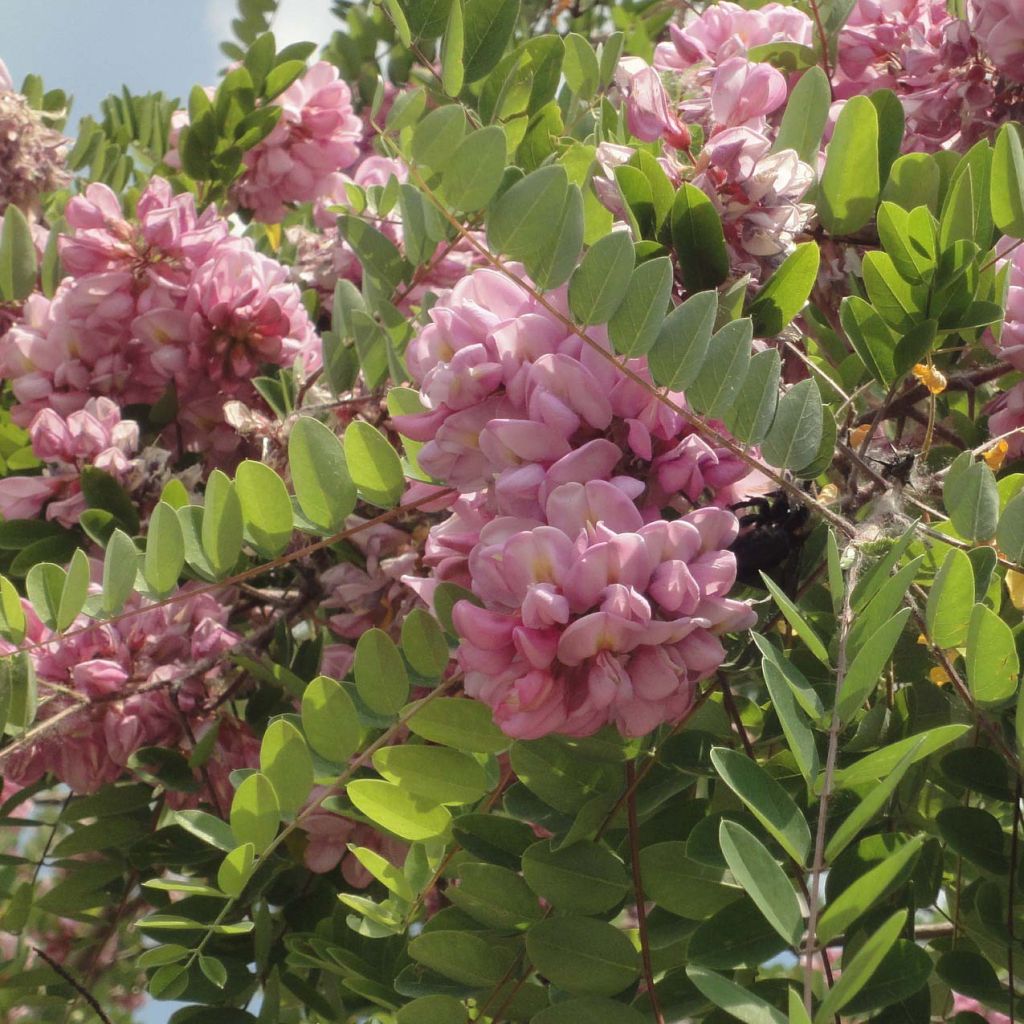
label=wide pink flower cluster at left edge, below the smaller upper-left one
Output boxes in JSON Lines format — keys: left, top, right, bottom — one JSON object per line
{"left": 0, "top": 177, "right": 321, "bottom": 460}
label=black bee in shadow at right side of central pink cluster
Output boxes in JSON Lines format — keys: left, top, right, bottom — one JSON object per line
{"left": 729, "top": 490, "right": 811, "bottom": 589}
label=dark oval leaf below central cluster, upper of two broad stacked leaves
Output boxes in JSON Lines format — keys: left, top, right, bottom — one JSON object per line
{"left": 522, "top": 840, "right": 630, "bottom": 913}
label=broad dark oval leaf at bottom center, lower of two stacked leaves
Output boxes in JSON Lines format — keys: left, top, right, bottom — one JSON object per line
{"left": 526, "top": 918, "right": 639, "bottom": 995}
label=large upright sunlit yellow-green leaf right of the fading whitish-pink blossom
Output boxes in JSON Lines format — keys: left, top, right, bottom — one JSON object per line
{"left": 817, "top": 96, "right": 881, "bottom": 234}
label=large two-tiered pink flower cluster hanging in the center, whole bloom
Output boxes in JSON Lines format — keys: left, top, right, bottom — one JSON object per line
{"left": 395, "top": 269, "right": 753, "bottom": 737}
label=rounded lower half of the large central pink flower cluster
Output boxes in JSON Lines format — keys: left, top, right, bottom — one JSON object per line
{"left": 454, "top": 480, "right": 757, "bottom": 739}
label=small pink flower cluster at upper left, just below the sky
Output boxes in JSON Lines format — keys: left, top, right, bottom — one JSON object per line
{"left": 234, "top": 60, "right": 362, "bottom": 223}
